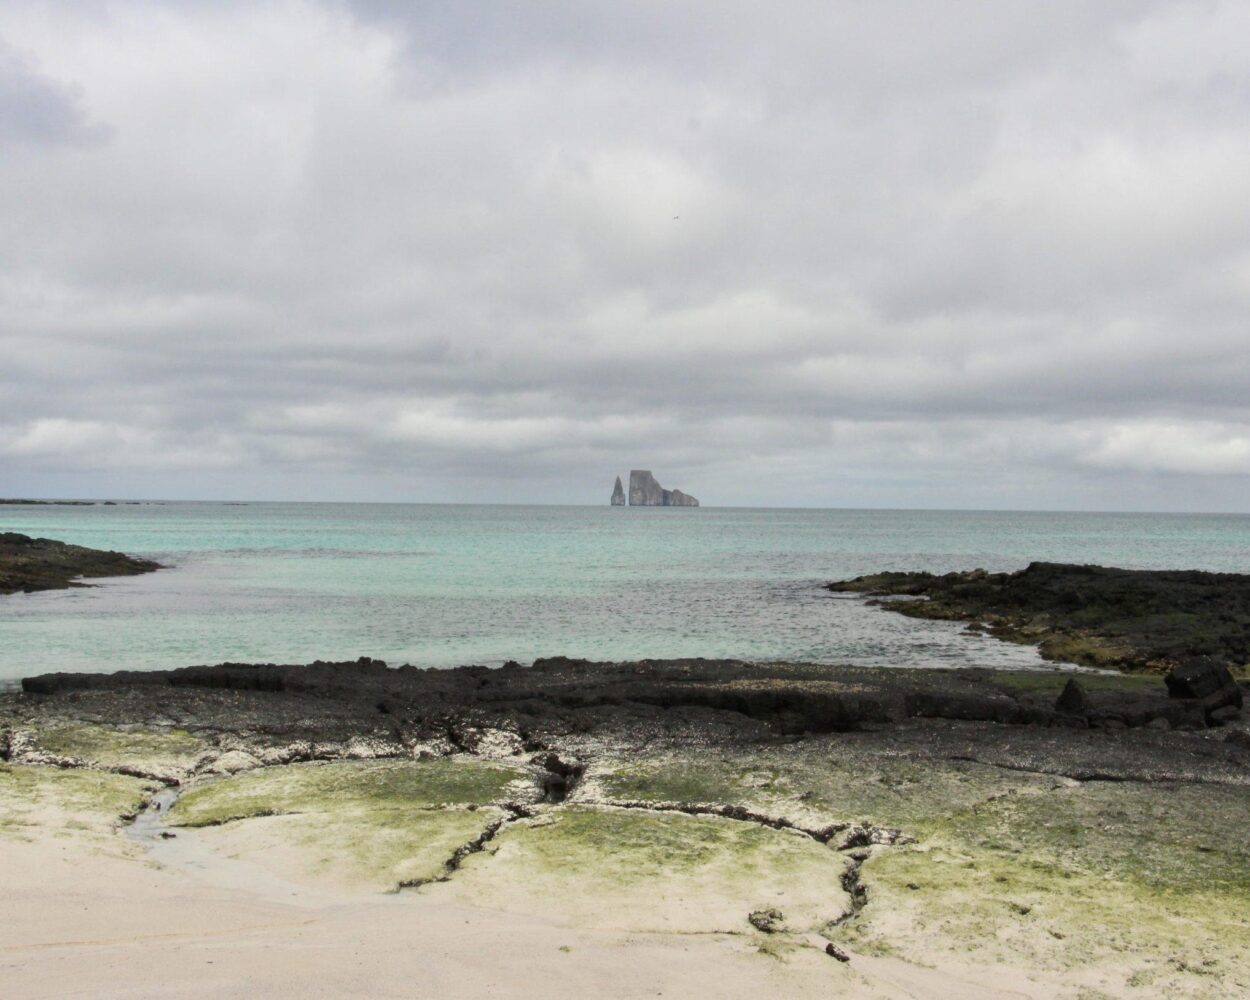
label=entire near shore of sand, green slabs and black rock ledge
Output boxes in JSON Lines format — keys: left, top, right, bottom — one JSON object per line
{"left": 0, "top": 659, "right": 1250, "bottom": 1000}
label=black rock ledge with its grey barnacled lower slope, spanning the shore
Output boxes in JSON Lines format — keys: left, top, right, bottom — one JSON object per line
{"left": 9, "top": 658, "right": 1250, "bottom": 795}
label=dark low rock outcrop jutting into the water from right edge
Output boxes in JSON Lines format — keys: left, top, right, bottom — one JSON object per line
{"left": 829, "top": 563, "right": 1250, "bottom": 673}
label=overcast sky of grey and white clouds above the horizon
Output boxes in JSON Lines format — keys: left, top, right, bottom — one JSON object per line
{"left": 0, "top": 0, "right": 1250, "bottom": 511}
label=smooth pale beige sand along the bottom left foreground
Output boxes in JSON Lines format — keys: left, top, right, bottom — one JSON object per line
{"left": 0, "top": 816, "right": 1055, "bottom": 999}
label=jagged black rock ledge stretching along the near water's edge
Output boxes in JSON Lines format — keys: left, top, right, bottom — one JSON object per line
{"left": 19, "top": 656, "right": 1250, "bottom": 740}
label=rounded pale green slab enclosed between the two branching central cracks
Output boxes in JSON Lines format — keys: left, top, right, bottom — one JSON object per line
{"left": 437, "top": 805, "right": 850, "bottom": 934}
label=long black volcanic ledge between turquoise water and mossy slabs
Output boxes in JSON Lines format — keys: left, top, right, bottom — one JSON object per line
{"left": 12, "top": 658, "right": 1206, "bottom": 740}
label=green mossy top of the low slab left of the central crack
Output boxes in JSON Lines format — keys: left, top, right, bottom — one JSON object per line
{"left": 169, "top": 758, "right": 529, "bottom": 826}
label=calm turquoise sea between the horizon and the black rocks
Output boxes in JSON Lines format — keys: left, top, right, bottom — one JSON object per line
{"left": 0, "top": 503, "right": 1250, "bottom": 681}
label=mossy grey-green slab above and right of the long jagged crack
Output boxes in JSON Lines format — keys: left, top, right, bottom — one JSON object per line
{"left": 588, "top": 740, "right": 1250, "bottom": 999}
